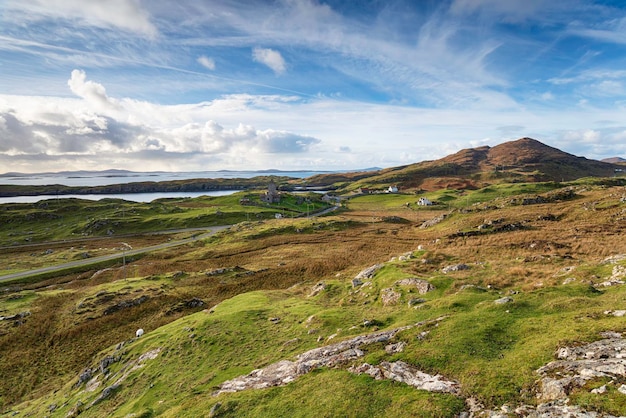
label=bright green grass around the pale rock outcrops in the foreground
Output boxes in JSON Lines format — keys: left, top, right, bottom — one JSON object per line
{"left": 12, "top": 253, "right": 626, "bottom": 417}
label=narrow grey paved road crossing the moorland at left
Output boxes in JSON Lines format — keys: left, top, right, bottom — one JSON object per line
{"left": 0, "top": 225, "right": 231, "bottom": 283}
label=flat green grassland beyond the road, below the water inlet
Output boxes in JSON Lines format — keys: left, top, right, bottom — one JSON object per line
{"left": 0, "top": 192, "right": 328, "bottom": 246}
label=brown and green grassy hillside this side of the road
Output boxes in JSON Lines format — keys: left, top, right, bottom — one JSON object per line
{"left": 0, "top": 179, "right": 626, "bottom": 417}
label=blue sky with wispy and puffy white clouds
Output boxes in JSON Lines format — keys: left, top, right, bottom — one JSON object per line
{"left": 0, "top": 0, "right": 626, "bottom": 173}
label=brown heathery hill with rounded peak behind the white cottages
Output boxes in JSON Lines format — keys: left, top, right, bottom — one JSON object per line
{"left": 308, "top": 138, "right": 623, "bottom": 191}
